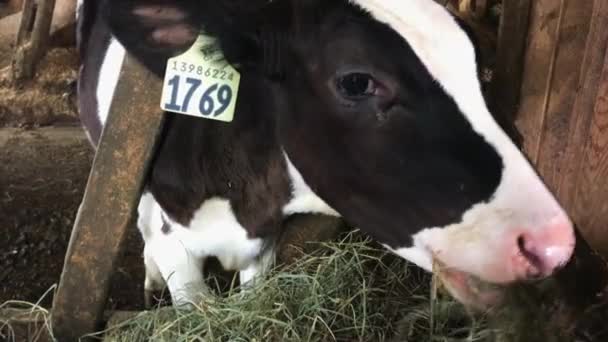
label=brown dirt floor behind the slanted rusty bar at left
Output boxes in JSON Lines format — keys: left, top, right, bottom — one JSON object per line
{"left": 0, "top": 45, "right": 143, "bottom": 310}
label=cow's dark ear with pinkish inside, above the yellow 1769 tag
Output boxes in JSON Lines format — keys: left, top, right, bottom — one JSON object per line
{"left": 102, "top": 0, "right": 291, "bottom": 77}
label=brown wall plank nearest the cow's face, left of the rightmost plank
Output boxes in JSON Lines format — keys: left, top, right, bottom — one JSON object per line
{"left": 517, "top": 0, "right": 593, "bottom": 167}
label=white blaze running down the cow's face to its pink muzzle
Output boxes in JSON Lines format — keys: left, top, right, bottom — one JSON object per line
{"left": 351, "top": 0, "right": 574, "bottom": 282}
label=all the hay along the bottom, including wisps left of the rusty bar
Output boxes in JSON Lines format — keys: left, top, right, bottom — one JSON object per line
{"left": 0, "top": 234, "right": 608, "bottom": 342}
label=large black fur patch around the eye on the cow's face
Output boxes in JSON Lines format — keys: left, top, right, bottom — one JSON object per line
{"left": 280, "top": 2, "right": 504, "bottom": 248}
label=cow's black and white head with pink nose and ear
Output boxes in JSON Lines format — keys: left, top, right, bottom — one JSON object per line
{"left": 108, "top": 0, "right": 575, "bottom": 308}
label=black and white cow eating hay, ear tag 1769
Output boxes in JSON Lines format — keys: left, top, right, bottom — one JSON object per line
{"left": 79, "top": 0, "right": 575, "bottom": 303}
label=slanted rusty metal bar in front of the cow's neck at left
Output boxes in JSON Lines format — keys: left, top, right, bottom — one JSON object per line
{"left": 51, "top": 55, "right": 164, "bottom": 342}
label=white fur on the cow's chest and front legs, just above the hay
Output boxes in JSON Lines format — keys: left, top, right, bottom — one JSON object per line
{"left": 138, "top": 193, "right": 266, "bottom": 305}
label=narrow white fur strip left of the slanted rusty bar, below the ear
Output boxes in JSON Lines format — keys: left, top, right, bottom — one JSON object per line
{"left": 96, "top": 37, "right": 125, "bottom": 125}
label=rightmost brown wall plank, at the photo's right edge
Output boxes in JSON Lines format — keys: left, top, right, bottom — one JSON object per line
{"left": 557, "top": 0, "right": 608, "bottom": 255}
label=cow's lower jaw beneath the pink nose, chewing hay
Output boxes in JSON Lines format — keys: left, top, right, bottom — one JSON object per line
{"left": 433, "top": 259, "right": 505, "bottom": 311}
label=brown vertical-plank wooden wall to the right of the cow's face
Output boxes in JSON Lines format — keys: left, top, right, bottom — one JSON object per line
{"left": 505, "top": 0, "right": 608, "bottom": 255}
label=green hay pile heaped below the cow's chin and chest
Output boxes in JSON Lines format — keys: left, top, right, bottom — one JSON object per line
{"left": 98, "top": 236, "right": 490, "bottom": 342}
